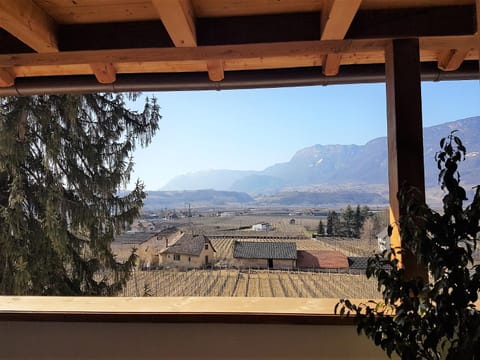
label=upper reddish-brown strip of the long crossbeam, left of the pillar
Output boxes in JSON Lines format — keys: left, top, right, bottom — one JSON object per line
{"left": 0, "top": 40, "right": 387, "bottom": 67}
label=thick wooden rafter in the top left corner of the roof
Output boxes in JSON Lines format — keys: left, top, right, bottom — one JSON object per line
{"left": 0, "top": 0, "right": 58, "bottom": 53}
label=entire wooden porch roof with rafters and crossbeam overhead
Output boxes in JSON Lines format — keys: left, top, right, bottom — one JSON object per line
{"left": 0, "top": 0, "right": 480, "bottom": 95}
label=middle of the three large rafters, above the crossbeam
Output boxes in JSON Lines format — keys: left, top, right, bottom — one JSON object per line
{"left": 152, "top": 0, "right": 197, "bottom": 47}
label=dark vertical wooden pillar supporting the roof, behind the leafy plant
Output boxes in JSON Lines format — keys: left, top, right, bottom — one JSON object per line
{"left": 385, "top": 39, "right": 427, "bottom": 278}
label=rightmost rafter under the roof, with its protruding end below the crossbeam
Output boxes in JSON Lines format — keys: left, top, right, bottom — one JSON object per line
{"left": 320, "top": 0, "right": 362, "bottom": 76}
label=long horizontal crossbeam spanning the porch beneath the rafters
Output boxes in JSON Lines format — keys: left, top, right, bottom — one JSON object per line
{"left": 0, "top": 35, "right": 479, "bottom": 77}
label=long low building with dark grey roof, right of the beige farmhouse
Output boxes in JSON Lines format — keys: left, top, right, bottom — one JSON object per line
{"left": 233, "top": 241, "right": 297, "bottom": 269}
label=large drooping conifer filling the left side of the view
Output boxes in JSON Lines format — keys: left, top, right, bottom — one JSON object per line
{"left": 0, "top": 94, "right": 160, "bottom": 295}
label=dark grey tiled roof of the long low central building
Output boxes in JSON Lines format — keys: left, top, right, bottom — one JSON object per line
{"left": 233, "top": 241, "right": 297, "bottom": 260}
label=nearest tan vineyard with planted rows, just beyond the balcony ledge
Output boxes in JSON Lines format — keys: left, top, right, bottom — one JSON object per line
{"left": 120, "top": 269, "right": 380, "bottom": 298}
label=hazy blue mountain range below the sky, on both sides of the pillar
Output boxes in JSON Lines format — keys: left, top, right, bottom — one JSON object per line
{"left": 162, "top": 116, "right": 480, "bottom": 194}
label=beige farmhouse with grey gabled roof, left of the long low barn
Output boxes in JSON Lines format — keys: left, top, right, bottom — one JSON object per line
{"left": 160, "top": 234, "right": 216, "bottom": 268}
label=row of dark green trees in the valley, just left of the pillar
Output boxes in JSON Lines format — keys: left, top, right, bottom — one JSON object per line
{"left": 317, "top": 205, "right": 386, "bottom": 239}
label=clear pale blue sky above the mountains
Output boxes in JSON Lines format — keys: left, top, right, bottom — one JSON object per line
{"left": 125, "top": 80, "right": 480, "bottom": 190}
